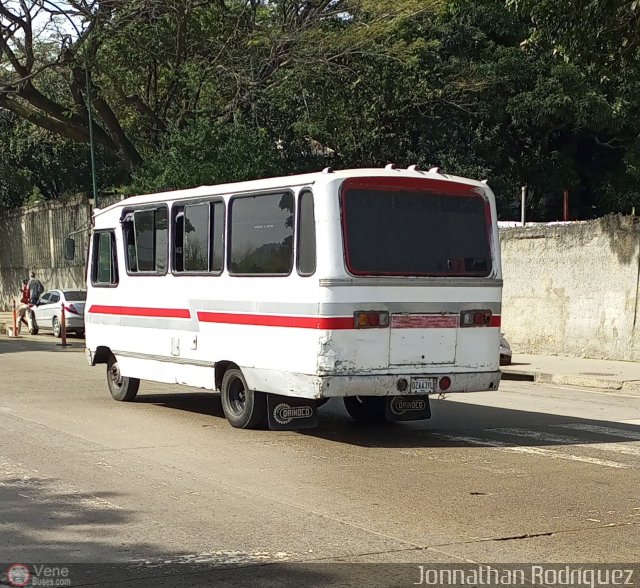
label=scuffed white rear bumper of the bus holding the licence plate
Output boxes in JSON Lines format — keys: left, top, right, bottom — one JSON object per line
{"left": 318, "top": 370, "right": 501, "bottom": 398}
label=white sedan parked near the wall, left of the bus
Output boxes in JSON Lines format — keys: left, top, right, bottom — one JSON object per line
{"left": 29, "top": 290, "right": 87, "bottom": 337}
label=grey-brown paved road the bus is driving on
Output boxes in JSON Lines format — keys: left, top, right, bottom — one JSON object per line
{"left": 0, "top": 336, "right": 640, "bottom": 586}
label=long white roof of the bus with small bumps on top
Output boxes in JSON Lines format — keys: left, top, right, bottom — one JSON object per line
{"left": 94, "top": 167, "right": 486, "bottom": 216}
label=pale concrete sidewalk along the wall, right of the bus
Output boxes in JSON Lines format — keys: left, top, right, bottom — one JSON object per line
{"left": 500, "top": 353, "right": 640, "bottom": 390}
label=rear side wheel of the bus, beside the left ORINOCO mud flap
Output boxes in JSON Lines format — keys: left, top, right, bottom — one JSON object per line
{"left": 220, "top": 369, "right": 267, "bottom": 429}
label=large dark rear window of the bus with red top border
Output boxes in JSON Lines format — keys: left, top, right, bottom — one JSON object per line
{"left": 341, "top": 179, "right": 491, "bottom": 276}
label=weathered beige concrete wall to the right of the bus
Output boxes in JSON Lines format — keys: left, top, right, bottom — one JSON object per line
{"left": 500, "top": 216, "right": 640, "bottom": 361}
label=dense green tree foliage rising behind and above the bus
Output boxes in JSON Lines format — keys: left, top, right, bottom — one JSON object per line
{"left": 0, "top": 0, "right": 640, "bottom": 219}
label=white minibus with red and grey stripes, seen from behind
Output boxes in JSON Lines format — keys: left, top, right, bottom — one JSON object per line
{"left": 77, "top": 166, "right": 502, "bottom": 429}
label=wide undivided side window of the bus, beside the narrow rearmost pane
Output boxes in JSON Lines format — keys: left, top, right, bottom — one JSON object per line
{"left": 229, "top": 192, "right": 294, "bottom": 276}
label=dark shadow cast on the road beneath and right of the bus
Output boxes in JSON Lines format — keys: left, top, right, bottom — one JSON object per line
{"left": 127, "top": 392, "right": 640, "bottom": 456}
